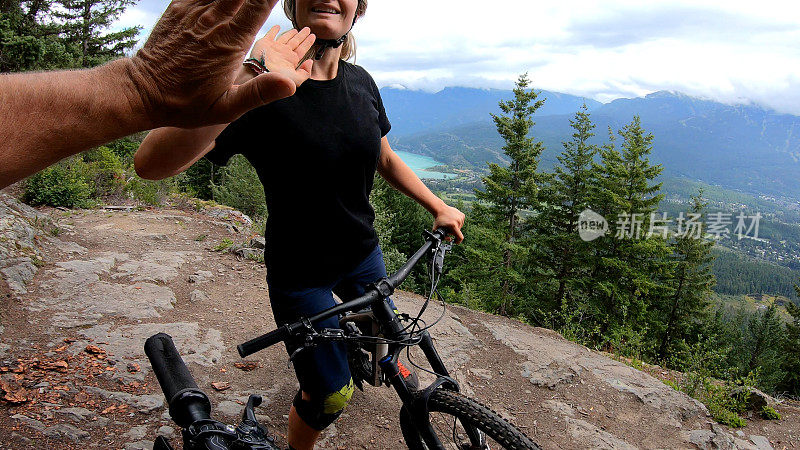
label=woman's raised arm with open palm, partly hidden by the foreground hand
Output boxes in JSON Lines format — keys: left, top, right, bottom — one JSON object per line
{"left": 134, "top": 26, "right": 315, "bottom": 180}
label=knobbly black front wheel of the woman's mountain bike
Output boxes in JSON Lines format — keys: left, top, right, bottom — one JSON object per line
{"left": 400, "top": 388, "right": 539, "bottom": 450}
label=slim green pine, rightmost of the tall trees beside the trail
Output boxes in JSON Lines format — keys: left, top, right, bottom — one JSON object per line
{"left": 654, "top": 191, "right": 714, "bottom": 361}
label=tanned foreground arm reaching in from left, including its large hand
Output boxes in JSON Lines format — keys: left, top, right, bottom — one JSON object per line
{"left": 0, "top": 0, "right": 296, "bottom": 188}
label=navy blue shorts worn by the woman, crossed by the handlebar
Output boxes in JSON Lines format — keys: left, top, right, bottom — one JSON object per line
{"left": 267, "top": 246, "right": 396, "bottom": 398}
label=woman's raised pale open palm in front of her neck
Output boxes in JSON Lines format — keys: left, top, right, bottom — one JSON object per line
{"left": 250, "top": 25, "right": 316, "bottom": 86}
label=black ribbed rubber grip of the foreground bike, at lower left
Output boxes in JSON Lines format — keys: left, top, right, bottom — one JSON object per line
{"left": 144, "top": 333, "right": 198, "bottom": 403}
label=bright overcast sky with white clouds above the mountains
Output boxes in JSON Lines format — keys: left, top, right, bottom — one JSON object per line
{"left": 119, "top": 0, "right": 800, "bottom": 115}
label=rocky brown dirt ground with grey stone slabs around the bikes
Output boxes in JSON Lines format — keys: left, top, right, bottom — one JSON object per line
{"left": 0, "top": 194, "right": 800, "bottom": 449}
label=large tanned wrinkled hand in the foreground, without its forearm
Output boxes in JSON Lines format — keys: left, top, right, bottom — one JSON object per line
{"left": 128, "top": 0, "right": 296, "bottom": 128}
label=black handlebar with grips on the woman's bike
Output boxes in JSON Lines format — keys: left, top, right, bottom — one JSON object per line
{"left": 236, "top": 228, "right": 447, "bottom": 358}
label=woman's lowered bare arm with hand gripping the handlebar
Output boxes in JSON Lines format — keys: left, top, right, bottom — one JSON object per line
{"left": 378, "top": 136, "right": 466, "bottom": 243}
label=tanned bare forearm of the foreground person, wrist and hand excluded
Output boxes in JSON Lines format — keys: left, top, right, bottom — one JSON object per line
{"left": 0, "top": 59, "right": 148, "bottom": 188}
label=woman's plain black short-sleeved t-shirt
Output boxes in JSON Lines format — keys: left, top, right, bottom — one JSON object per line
{"left": 206, "top": 61, "right": 391, "bottom": 287}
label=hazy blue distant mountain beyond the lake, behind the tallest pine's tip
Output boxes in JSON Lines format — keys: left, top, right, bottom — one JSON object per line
{"left": 381, "top": 87, "right": 602, "bottom": 137}
